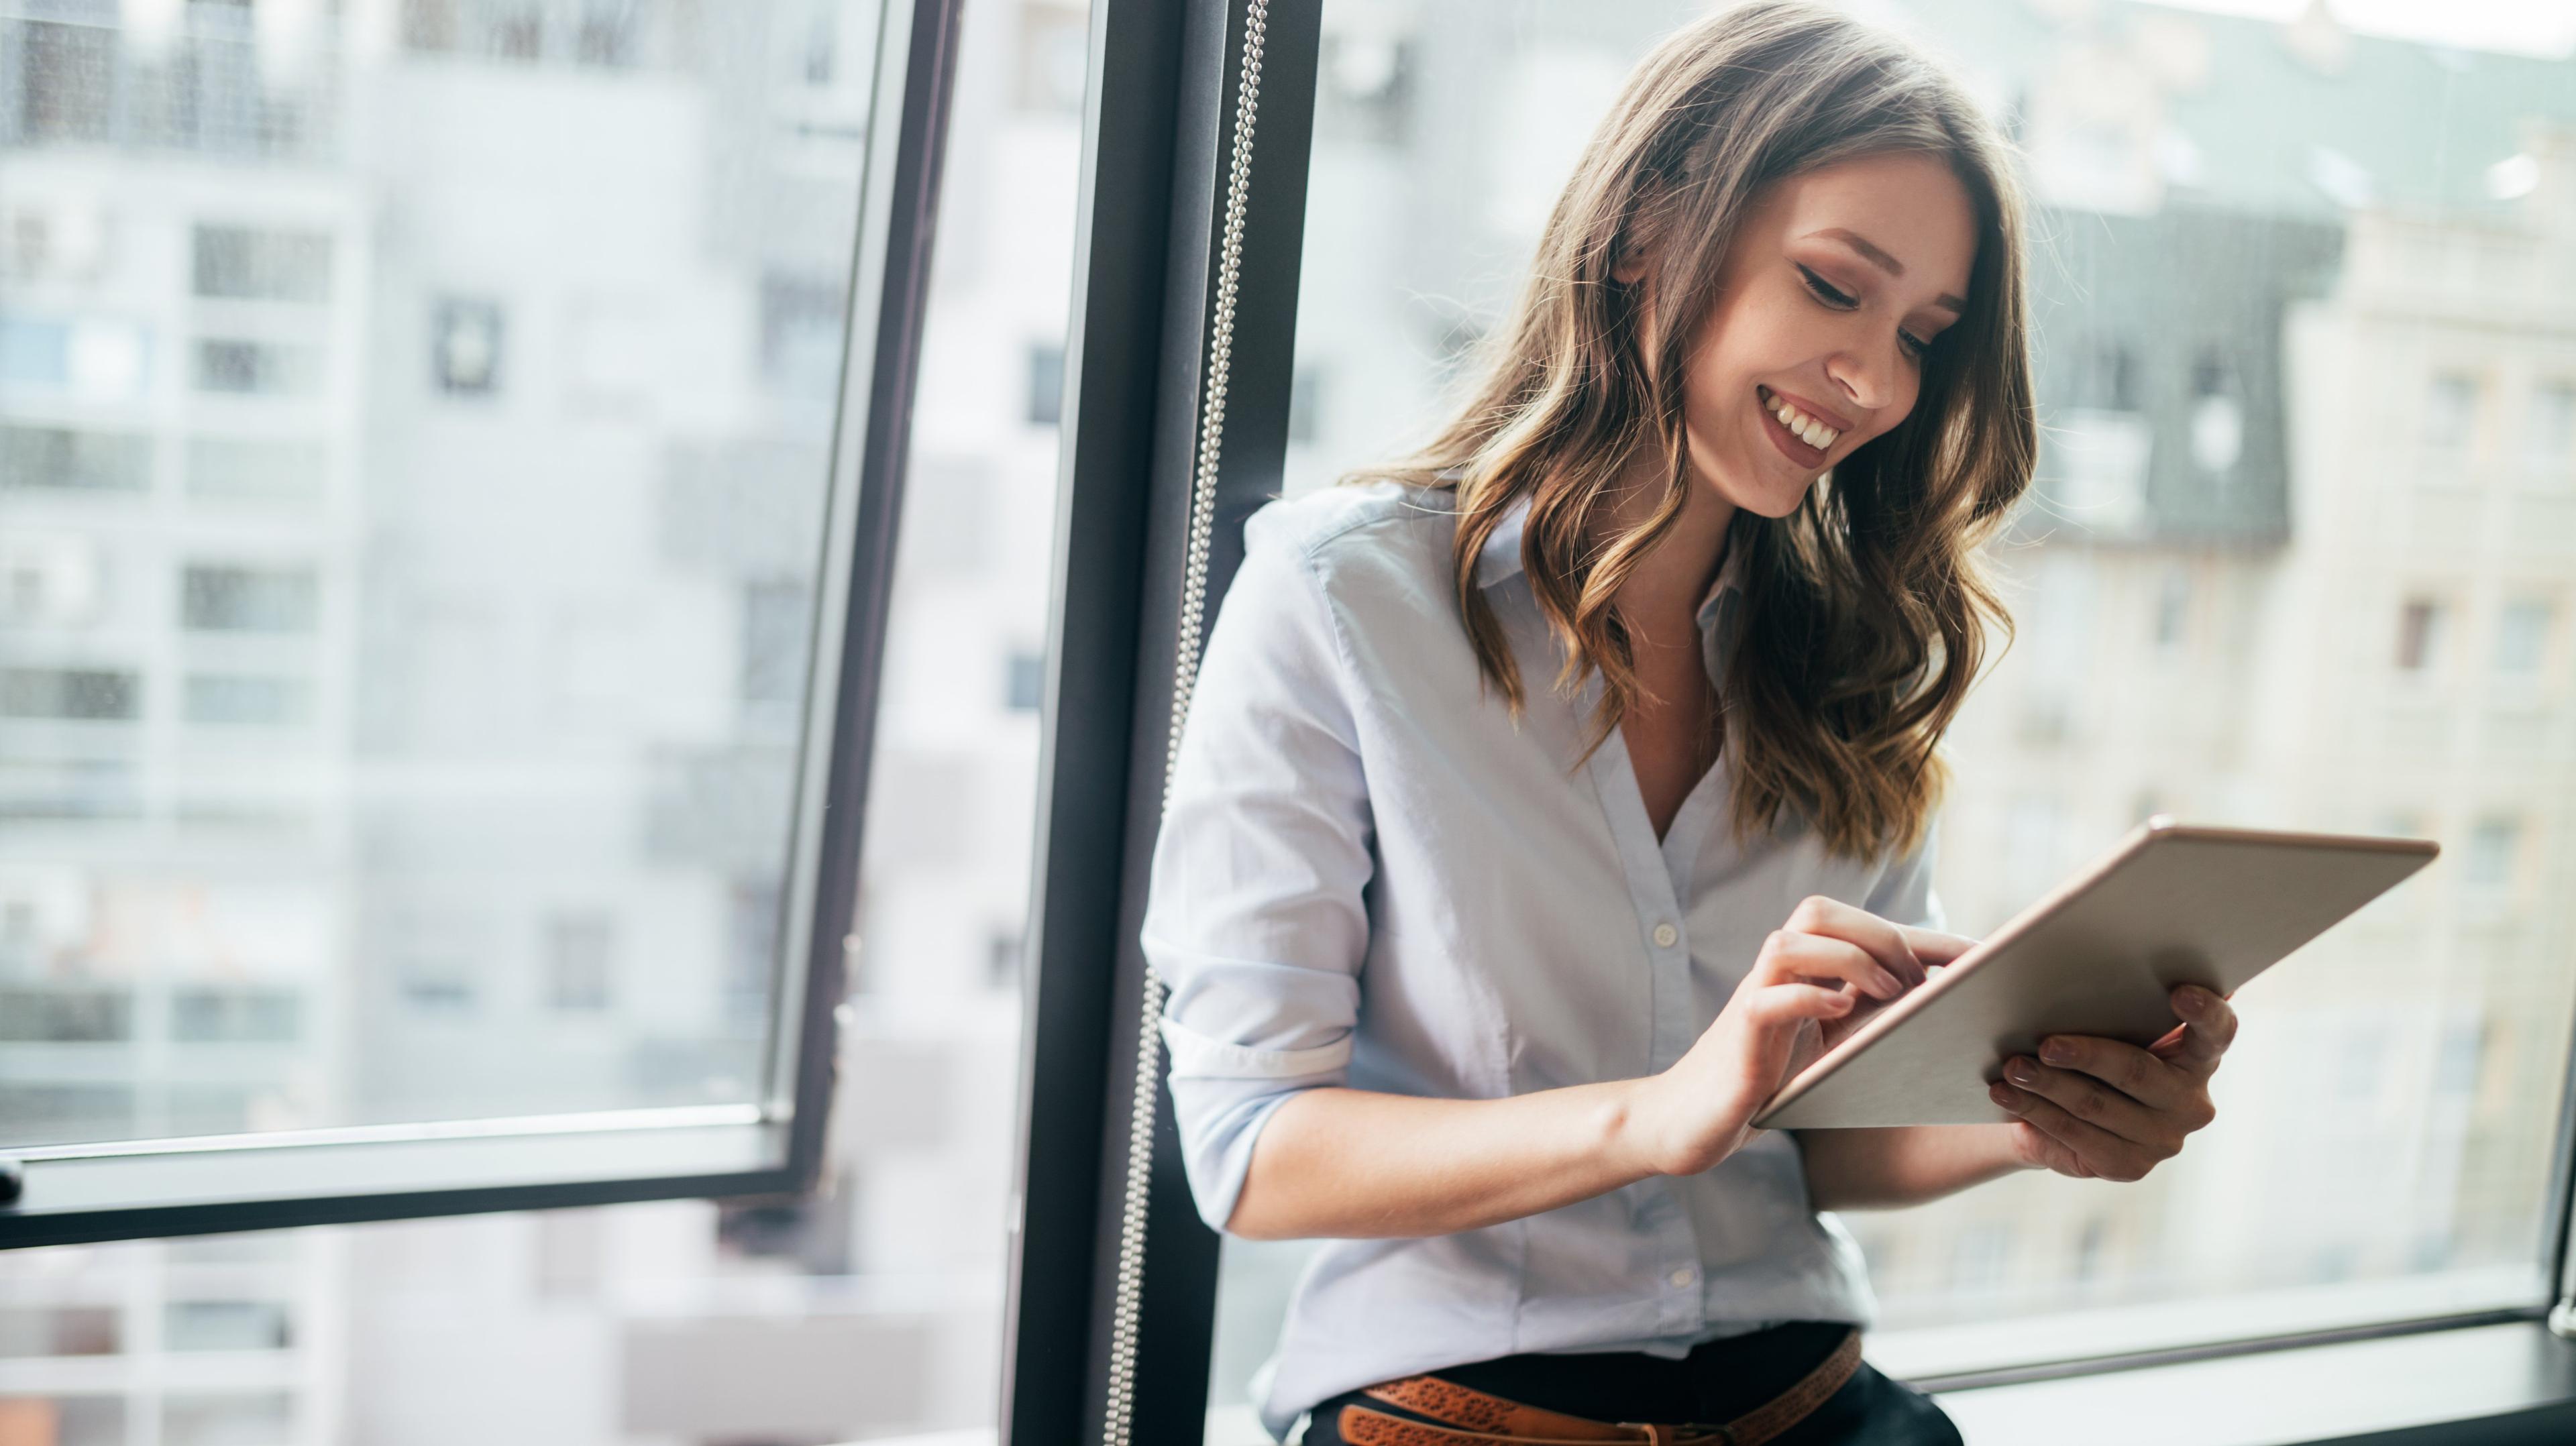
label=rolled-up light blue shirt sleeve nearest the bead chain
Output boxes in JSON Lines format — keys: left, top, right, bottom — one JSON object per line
{"left": 1144, "top": 510, "right": 1373, "bottom": 1229}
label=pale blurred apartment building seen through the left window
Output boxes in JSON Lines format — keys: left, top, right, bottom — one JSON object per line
{"left": 0, "top": 0, "right": 1087, "bottom": 1446}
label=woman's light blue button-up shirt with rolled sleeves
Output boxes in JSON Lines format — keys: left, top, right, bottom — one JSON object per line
{"left": 1144, "top": 482, "right": 1940, "bottom": 1436}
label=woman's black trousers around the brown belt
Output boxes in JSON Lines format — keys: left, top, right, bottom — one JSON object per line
{"left": 1303, "top": 1320, "right": 1960, "bottom": 1446}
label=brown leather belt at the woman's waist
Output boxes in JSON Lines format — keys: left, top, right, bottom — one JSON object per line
{"left": 1337, "top": 1330, "right": 1860, "bottom": 1446}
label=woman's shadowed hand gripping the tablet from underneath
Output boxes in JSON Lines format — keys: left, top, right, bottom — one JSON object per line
{"left": 1988, "top": 985, "right": 2236, "bottom": 1180}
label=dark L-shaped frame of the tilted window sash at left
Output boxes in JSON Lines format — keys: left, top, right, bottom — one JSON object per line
{"left": 0, "top": 0, "right": 963, "bottom": 1250}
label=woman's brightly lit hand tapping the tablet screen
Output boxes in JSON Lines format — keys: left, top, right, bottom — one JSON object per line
{"left": 1625, "top": 897, "right": 1976, "bottom": 1175}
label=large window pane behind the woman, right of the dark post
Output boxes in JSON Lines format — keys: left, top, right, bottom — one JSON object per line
{"left": 1211, "top": 0, "right": 2576, "bottom": 1441}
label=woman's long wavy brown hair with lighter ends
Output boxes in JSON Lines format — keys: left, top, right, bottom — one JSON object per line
{"left": 1352, "top": 0, "right": 2037, "bottom": 858}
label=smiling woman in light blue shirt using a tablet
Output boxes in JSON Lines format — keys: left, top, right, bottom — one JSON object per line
{"left": 1144, "top": 3, "right": 2233, "bottom": 1446}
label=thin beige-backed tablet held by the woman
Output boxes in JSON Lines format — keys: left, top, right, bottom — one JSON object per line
{"left": 1754, "top": 814, "right": 2439, "bottom": 1129}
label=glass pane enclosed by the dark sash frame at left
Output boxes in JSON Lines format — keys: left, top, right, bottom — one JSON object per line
{"left": 0, "top": 0, "right": 876, "bottom": 1150}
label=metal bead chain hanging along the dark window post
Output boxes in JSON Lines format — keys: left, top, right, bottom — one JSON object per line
{"left": 1100, "top": 0, "right": 1270, "bottom": 1446}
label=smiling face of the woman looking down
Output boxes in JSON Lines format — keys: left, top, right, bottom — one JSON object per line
{"left": 1648, "top": 152, "right": 1976, "bottom": 518}
